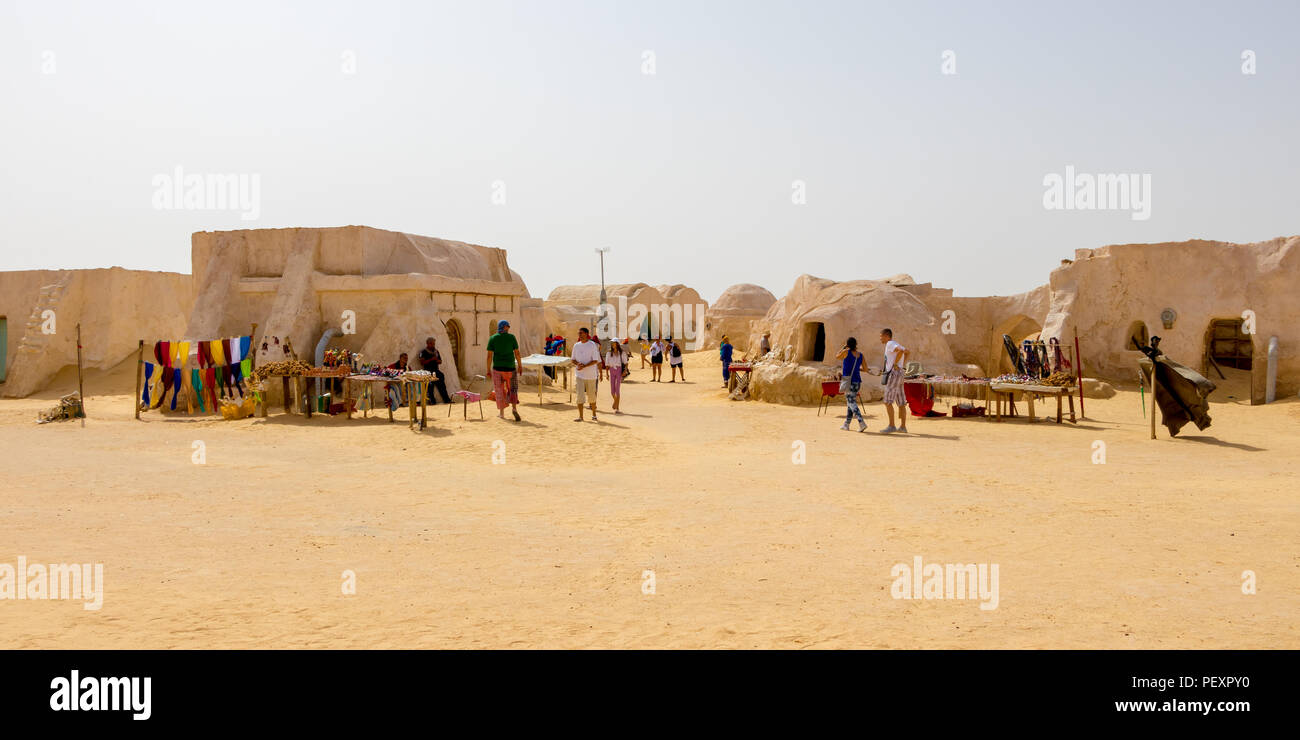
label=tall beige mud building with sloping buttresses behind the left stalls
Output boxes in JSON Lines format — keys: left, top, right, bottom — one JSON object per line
{"left": 186, "top": 226, "right": 542, "bottom": 391}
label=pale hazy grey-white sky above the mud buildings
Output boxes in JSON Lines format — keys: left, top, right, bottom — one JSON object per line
{"left": 0, "top": 0, "right": 1300, "bottom": 300}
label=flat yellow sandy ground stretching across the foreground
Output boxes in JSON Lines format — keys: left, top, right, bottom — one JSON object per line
{"left": 0, "top": 352, "right": 1300, "bottom": 649}
